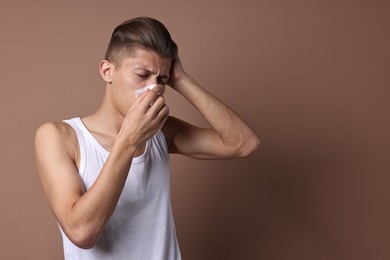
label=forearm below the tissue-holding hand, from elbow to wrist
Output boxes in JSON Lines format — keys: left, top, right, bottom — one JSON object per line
{"left": 66, "top": 140, "right": 134, "bottom": 248}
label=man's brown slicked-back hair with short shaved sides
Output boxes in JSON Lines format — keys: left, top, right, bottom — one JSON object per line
{"left": 105, "top": 17, "right": 177, "bottom": 67}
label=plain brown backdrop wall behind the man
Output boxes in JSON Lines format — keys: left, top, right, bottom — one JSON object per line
{"left": 0, "top": 0, "right": 390, "bottom": 260}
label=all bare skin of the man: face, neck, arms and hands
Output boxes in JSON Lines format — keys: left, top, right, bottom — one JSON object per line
{"left": 35, "top": 48, "right": 260, "bottom": 248}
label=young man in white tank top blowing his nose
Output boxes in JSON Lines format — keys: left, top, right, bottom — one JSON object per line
{"left": 35, "top": 17, "right": 259, "bottom": 260}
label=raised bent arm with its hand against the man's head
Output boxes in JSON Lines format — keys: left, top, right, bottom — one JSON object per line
{"left": 163, "top": 55, "right": 260, "bottom": 159}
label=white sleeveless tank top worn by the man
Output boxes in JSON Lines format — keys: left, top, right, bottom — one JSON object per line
{"left": 60, "top": 118, "right": 181, "bottom": 260}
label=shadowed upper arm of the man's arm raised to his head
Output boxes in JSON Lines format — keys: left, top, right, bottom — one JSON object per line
{"left": 163, "top": 117, "right": 241, "bottom": 159}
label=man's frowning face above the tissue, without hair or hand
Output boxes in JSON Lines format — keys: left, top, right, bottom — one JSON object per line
{"left": 103, "top": 49, "right": 171, "bottom": 114}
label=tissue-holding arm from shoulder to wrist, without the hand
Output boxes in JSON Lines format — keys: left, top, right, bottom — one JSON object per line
{"left": 35, "top": 123, "right": 133, "bottom": 248}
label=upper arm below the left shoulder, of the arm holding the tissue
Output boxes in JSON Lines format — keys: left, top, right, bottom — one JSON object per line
{"left": 35, "top": 123, "right": 84, "bottom": 222}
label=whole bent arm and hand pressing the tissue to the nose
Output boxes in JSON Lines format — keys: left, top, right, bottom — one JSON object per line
{"left": 35, "top": 90, "right": 168, "bottom": 248}
